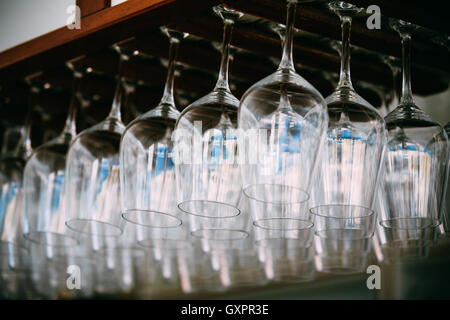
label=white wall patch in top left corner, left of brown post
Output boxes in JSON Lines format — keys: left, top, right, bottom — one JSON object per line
{"left": 0, "top": 0, "right": 75, "bottom": 51}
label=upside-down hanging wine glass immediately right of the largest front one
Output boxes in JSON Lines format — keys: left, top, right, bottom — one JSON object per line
{"left": 314, "top": 1, "right": 386, "bottom": 211}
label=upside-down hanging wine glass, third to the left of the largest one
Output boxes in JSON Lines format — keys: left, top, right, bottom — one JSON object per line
{"left": 64, "top": 45, "right": 129, "bottom": 236}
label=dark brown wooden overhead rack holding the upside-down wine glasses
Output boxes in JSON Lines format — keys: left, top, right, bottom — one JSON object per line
{"left": 0, "top": 0, "right": 450, "bottom": 145}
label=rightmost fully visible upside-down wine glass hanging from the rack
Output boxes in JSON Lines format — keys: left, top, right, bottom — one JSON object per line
{"left": 379, "top": 21, "right": 448, "bottom": 231}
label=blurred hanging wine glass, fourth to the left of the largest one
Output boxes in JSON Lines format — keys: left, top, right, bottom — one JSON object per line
{"left": 23, "top": 62, "right": 84, "bottom": 247}
